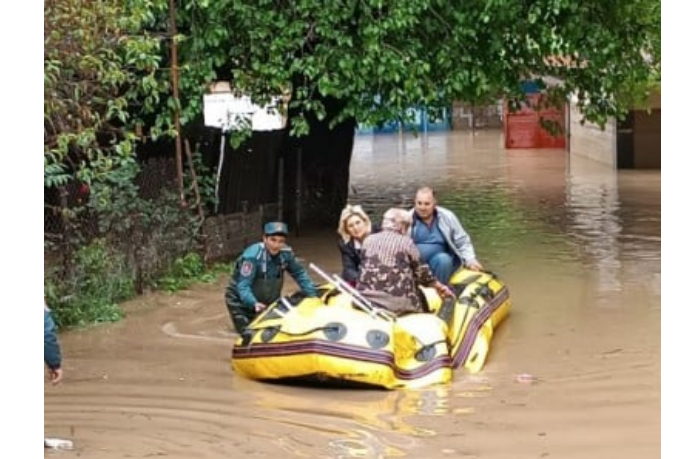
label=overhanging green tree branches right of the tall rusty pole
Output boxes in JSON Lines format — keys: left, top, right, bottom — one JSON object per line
{"left": 171, "top": 0, "right": 661, "bottom": 133}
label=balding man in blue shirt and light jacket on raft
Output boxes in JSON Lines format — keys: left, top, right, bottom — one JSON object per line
{"left": 410, "top": 187, "right": 484, "bottom": 284}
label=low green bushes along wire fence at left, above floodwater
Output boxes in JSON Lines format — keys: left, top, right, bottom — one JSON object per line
{"left": 44, "top": 157, "right": 227, "bottom": 328}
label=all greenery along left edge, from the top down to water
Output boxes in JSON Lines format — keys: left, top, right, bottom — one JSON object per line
{"left": 44, "top": 0, "right": 201, "bottom": 325}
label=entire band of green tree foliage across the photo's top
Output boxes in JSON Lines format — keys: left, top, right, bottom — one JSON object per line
{"left": 44, "top": 0, "right": 661, "bottom": 162}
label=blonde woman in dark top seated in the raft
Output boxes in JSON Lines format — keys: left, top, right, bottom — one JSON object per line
{"left": 338, "top": 204, "right": 372, "bottom": 286}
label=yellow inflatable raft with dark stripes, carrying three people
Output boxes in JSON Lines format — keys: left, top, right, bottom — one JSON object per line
{"left": 231, "top": 264, "right": 511, "bottom": 389}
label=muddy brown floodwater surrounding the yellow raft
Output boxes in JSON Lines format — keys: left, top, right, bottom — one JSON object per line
{"left": 44, "top": 131, "right": 661, "bottom": 459}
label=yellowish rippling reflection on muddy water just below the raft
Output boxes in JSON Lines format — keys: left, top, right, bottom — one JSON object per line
{"left": 241, "top": 381, "right": 498, "bottom": 458}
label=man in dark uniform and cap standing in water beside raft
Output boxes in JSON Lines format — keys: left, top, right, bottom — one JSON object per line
{"left": 225, "top": 222, "right": 318, "bottom": 333}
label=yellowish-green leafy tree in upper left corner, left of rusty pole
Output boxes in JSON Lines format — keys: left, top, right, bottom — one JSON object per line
{"left": 44, "top": 0, "right": 167, "bottom": 187}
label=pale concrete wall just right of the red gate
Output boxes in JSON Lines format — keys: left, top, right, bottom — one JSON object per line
{"left": 568, "top": 101, "right": 617, "bottom": 168}
